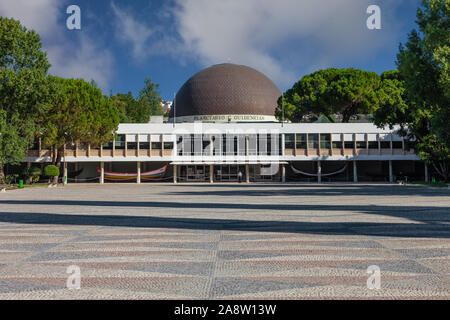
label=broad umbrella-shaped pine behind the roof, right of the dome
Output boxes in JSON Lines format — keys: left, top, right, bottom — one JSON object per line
{"left": 275, "top": 68, "right": 381, "bottom": 122}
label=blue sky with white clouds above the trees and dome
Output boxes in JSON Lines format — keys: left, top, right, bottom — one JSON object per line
{"left": 0, "top": 0, "right": 420, "bottom": 100}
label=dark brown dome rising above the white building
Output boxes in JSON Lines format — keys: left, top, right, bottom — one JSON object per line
{"left": 170, "top": 63, "right": 281, "bottom": 118}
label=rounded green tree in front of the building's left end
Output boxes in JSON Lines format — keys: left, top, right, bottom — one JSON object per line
{"left": 39, "top": 76, "right": 119, "bottom": 182}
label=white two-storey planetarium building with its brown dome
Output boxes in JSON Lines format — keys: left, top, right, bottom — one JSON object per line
{"left": 27, "top": 64, "right": 429, "bottom": 183}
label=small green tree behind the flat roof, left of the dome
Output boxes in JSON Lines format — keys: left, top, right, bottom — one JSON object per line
{"left": 111, "top": 92, "right": 151, "bottom": 123}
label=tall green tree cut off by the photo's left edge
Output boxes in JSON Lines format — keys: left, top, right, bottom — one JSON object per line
{"left": 0, "top": 17, "right": 50, "bottom": 184}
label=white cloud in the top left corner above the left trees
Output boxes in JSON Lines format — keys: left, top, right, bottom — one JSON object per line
{"left": 0, "top": 0, "right": 113, "bottom": 90}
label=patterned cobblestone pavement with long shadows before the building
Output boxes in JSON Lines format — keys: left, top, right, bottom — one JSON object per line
{"left": 0, "top": 184, "right": 450, "bottom": 299}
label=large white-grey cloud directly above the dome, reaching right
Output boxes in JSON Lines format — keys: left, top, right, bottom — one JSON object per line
{"left": 172, "top": 0, "right": 401, "bottom": 86}
